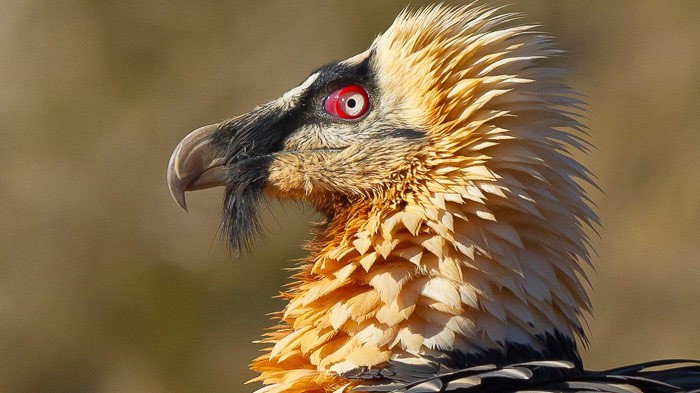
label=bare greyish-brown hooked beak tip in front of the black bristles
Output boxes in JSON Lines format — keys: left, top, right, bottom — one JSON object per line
{"left": 167, "top": 124, "right": 226, "bottom": 211}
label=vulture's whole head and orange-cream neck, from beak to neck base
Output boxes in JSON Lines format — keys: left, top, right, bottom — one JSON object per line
{"left": 167, "top": 6, "right": 597, "bottom": 392}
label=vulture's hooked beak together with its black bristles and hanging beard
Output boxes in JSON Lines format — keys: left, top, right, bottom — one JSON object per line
{"left": 167, "top": 101, "right": 302, "bottom": 254}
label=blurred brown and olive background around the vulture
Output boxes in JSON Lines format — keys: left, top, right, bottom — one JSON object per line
{"left": 0, "top": 0, "right": 700, "bottom": 393}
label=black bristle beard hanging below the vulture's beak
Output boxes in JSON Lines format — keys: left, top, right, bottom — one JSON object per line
{"left": 221, "top": 156, "right": 271, "bottom": 257}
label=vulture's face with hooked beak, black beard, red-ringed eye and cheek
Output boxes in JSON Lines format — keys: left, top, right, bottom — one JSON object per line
{"left": 168, "top": 48, "right": 427, "bottom": 252}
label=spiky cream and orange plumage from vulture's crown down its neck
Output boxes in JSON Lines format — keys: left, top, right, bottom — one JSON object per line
{"left": 246, "top": 7, "right": 597, "bottom": 392}
